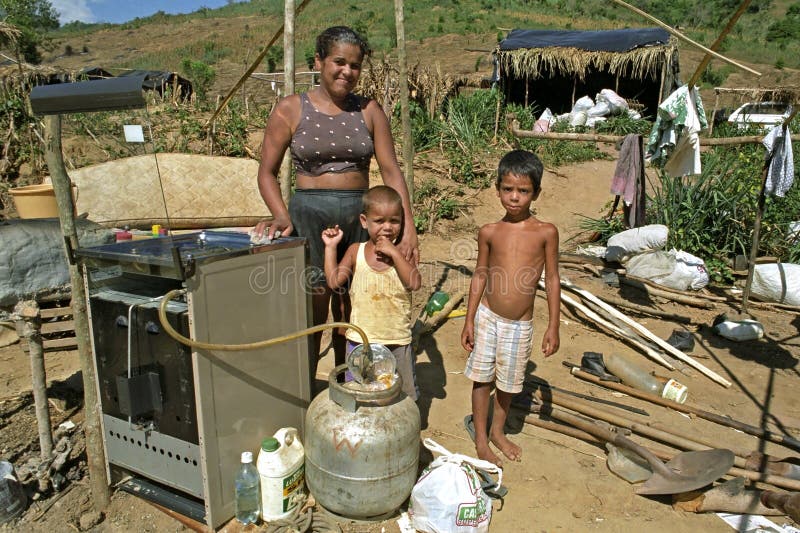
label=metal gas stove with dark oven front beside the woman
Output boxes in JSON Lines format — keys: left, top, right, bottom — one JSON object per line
{"left": 76, "top": 231, "right": 312, "bottom": 528}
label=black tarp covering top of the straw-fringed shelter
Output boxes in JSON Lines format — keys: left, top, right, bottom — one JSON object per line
{"left": 500, "top": 28, "right": 669, "bottom": 52}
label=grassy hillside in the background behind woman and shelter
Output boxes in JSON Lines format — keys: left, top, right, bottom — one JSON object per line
{"left": 46, "top": 0, "right": 800, "bottom": 97}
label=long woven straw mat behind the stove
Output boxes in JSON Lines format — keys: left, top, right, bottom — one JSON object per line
{"left": 69, "top": 154, "right": 269, "bottom": 225}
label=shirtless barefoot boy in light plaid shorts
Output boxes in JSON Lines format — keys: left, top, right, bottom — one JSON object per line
{"left": 461, "top": 150, "right": 561, "bottom": 466}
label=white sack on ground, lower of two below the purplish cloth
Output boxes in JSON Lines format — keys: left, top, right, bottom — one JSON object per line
{"left": 625, "top": 249, "right": 709, "bottom": 291}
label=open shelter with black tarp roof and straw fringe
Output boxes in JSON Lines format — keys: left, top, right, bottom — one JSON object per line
{"left": 495, "top": 28, "right": 678, "bottom": 116}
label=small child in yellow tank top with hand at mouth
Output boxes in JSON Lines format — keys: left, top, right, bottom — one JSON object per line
{"left": 322, "top": 185, "right": 422, "bottom": 401}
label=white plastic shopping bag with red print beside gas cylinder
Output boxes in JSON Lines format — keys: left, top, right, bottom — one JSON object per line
{"left": 408, "top": 439, "right": 503, "bottom": 533}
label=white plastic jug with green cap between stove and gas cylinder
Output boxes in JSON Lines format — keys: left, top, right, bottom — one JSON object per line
{"left": 257, "top": 428, "right": 306, "bottom": 522}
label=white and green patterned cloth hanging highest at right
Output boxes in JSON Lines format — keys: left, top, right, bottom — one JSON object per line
{"left": 647, "top": 85, "right": 708, "bottom": 177}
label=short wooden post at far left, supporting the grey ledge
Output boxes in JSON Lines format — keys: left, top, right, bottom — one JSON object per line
{"left": 14, "top": 300, "right": 53, "bottom": 461}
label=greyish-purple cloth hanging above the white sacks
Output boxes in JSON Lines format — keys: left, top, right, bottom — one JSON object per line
{"left": 611, "top": 133, "right": 646, "bottom": 228}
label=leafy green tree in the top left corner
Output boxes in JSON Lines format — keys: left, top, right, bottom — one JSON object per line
{"left": 0, "top": 0, "right": 59, "bottom": 64}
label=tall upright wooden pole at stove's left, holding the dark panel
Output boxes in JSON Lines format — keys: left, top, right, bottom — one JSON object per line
{"left": 44, "top": 115, "right": 111, "bottom": 511}
